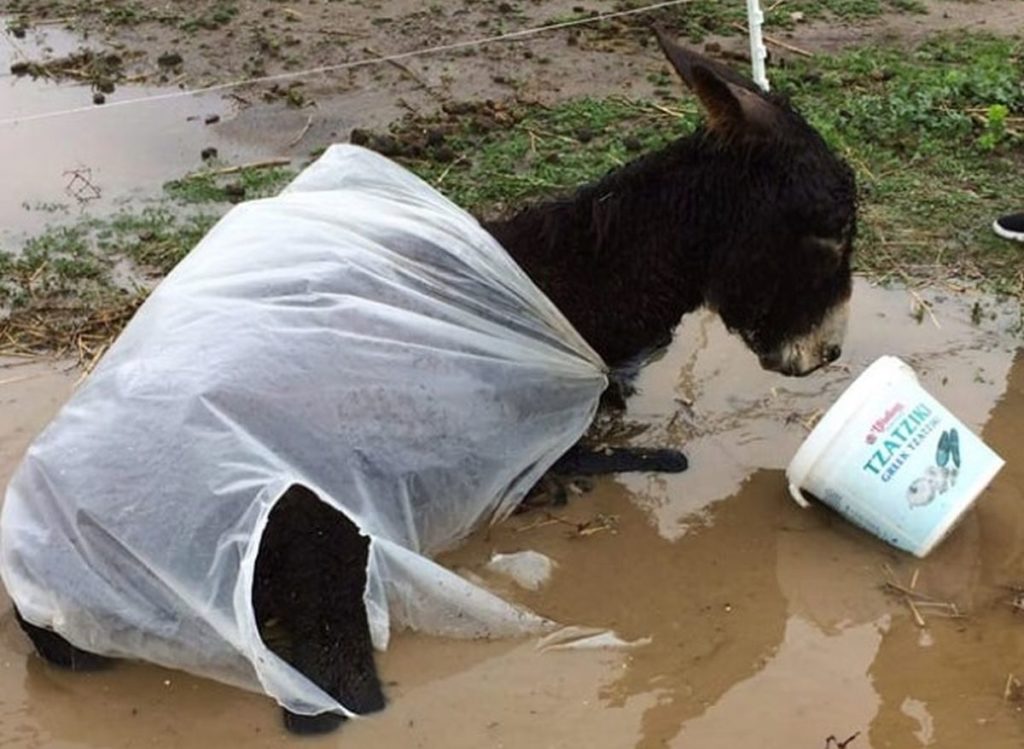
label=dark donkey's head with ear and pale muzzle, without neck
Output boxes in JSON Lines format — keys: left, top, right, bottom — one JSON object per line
{"left": 657, "top": 31, "right": 856, "bottom": 375}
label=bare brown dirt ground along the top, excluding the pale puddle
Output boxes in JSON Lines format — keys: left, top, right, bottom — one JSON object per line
{"left": 8, "top": 0, "right": 1024, "bottom": 136}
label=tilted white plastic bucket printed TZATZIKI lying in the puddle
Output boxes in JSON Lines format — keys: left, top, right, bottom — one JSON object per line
{"left": 785, "top": 357, "right": 1004, "bottom": 556}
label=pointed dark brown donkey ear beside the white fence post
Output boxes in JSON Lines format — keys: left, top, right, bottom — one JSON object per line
{"left": 654, "top": 29, "right": 781, "bottom": 137}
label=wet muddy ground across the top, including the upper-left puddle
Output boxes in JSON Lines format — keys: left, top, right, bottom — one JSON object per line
{"left": 9, "top": 0, "right": 1022, "bottom": 245}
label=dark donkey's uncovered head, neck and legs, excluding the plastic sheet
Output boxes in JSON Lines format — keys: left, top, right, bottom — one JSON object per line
{"left": 18, "top": 31, "right": 856, "bottom": 734}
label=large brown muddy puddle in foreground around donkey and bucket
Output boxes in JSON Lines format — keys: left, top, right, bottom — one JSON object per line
{"left": 0, "top": 283, "right": 1024, "bottom": 749}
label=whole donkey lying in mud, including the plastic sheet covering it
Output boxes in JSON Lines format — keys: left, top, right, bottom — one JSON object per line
{"left": 0, "top": 36, "right": 855, "bottom": 731}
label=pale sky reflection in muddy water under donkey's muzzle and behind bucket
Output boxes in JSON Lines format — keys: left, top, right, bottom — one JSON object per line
{"left": 623, "top": 280, "right": 1021, "bottom": 538}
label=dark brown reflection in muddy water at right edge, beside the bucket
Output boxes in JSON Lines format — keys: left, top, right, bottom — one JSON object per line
{"left": 871, "top": 348, "right": 1024, "bottom": 747}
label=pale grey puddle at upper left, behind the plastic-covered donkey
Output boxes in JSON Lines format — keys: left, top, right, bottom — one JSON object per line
{"left": 0, "top": 22, "right": 306, "bottom": 242}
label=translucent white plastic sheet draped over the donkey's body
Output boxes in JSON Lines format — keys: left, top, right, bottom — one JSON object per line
{"left": 0, "top": 145, "right": 606, "bottom": 713}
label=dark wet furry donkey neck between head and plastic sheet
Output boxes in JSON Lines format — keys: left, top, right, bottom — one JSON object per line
{"left": 486, "top": 136, "right": 707, "bottom": 366}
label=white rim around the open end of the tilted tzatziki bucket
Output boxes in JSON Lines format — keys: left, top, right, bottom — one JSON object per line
{"left": 785, "top": 356, "right": 916, "bottom": 507}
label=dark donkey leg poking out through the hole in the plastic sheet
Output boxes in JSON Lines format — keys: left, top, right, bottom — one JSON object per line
{"left": 253, "top": 486, "right": 384, "bottom": 734}
